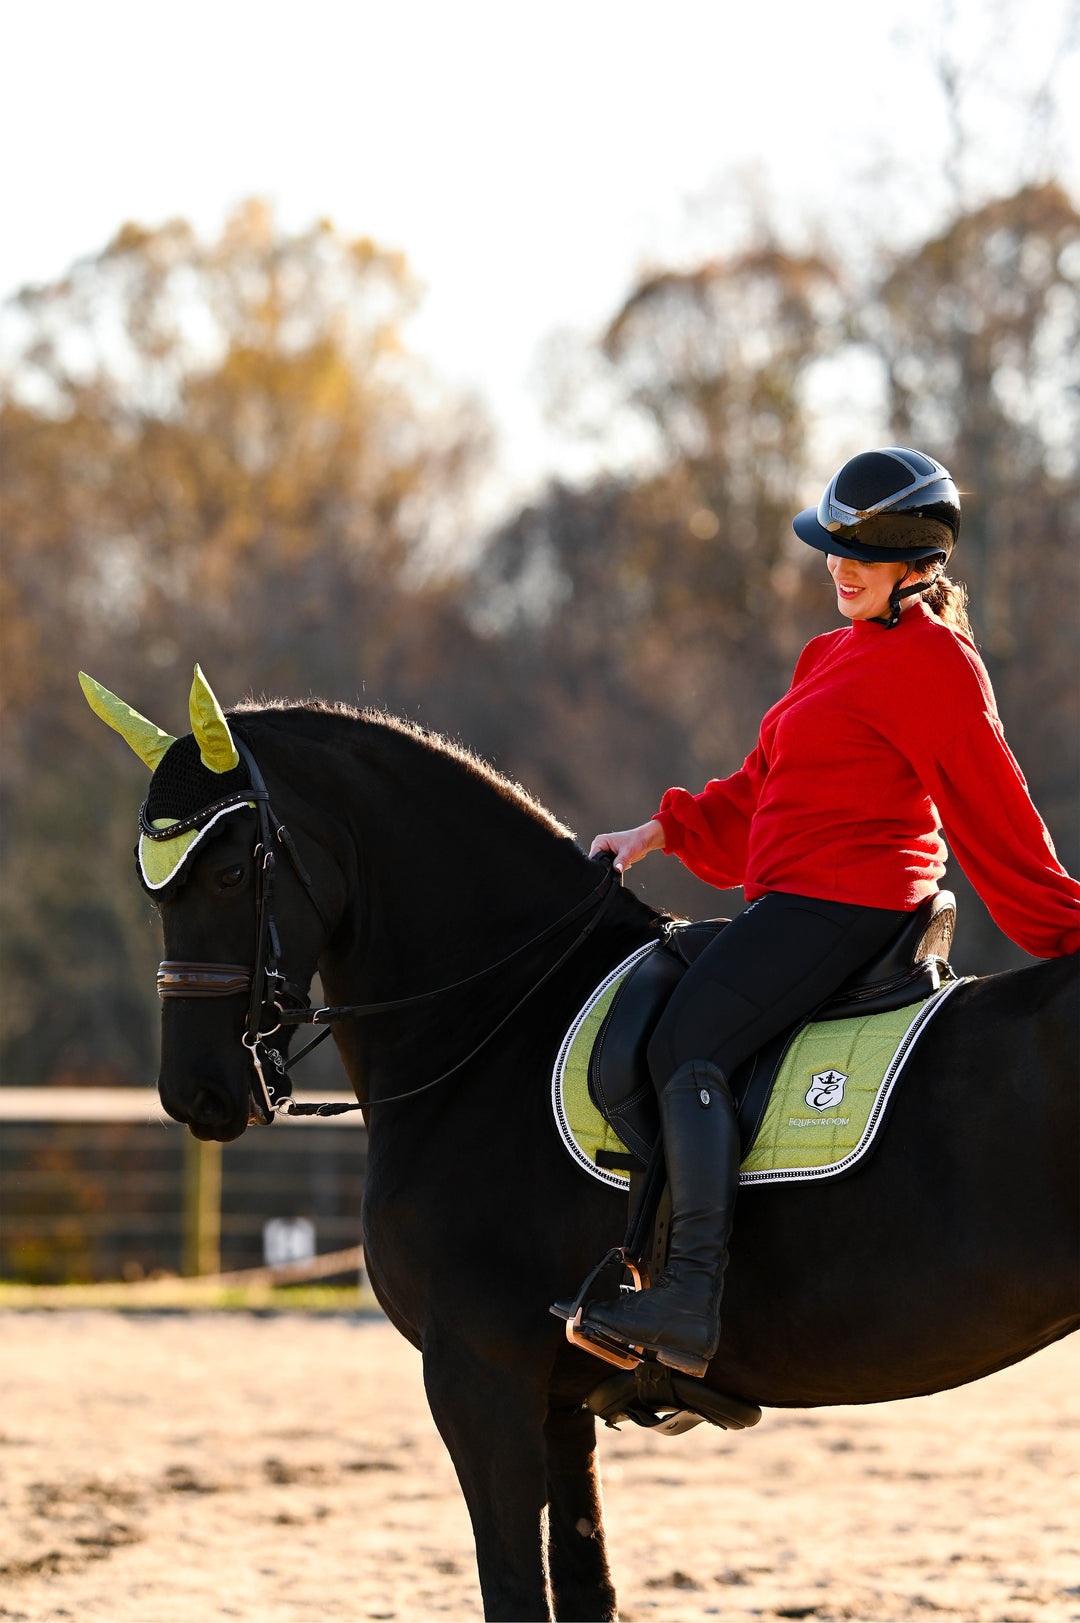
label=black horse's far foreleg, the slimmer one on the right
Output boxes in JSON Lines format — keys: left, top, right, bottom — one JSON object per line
{"left": 544, "top": 1397, "right": 619, "bottom": 1623}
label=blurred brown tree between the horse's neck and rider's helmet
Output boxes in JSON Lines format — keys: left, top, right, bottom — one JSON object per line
{"left": 477, "top": 239, "right": 846, "bottom": 912}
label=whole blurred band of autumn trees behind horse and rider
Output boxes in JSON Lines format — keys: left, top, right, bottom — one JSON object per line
{"left": 0, "top": 185, "right": 1080, "bottom": 1083}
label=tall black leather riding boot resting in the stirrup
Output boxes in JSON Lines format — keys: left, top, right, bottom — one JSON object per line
{"left": 581, "top": 1060, "right": 739, "bottom": 1375}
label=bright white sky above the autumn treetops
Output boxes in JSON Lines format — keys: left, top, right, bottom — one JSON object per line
{"left": 0, "top": 0, "right": 1080, "bottom": 500}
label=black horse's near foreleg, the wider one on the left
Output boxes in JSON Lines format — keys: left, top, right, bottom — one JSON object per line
{"left": 424, "top": 1334, "right": 551, "bottom": 1623}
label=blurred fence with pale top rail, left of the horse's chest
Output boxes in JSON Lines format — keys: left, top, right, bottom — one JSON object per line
{"left": 0, "top": 1087, "right": 367, "bottom": 1284}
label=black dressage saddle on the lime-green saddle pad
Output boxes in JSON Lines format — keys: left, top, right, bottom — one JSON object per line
{"left": 588, "top": 891, "right": 957, "bottom": 1173}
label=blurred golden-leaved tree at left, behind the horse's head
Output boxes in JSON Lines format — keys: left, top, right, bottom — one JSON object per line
{"left": 0, "top": 203, "right": 486, "bottom": 1081}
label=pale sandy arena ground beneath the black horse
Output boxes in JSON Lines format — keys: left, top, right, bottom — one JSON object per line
{"left": 0, "top": 1313, "right": 1080, "bottom": 1623}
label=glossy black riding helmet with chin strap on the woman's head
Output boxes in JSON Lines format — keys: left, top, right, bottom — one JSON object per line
{"left": 791, "top": 445, "right": 960, "bottom": 630}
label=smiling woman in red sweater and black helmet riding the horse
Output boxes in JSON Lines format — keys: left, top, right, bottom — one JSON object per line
{"left": 580, "top": 446, "right": 1080, "bottom": 1375}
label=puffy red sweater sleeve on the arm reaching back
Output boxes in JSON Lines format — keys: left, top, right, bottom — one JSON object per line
{"left": 913, "top": 709, "right": 1080, "bottom": 958}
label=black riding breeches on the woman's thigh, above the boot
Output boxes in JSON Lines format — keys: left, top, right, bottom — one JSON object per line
{"left": 648, "top": 891, "right": 911, "bottom": 1089}
